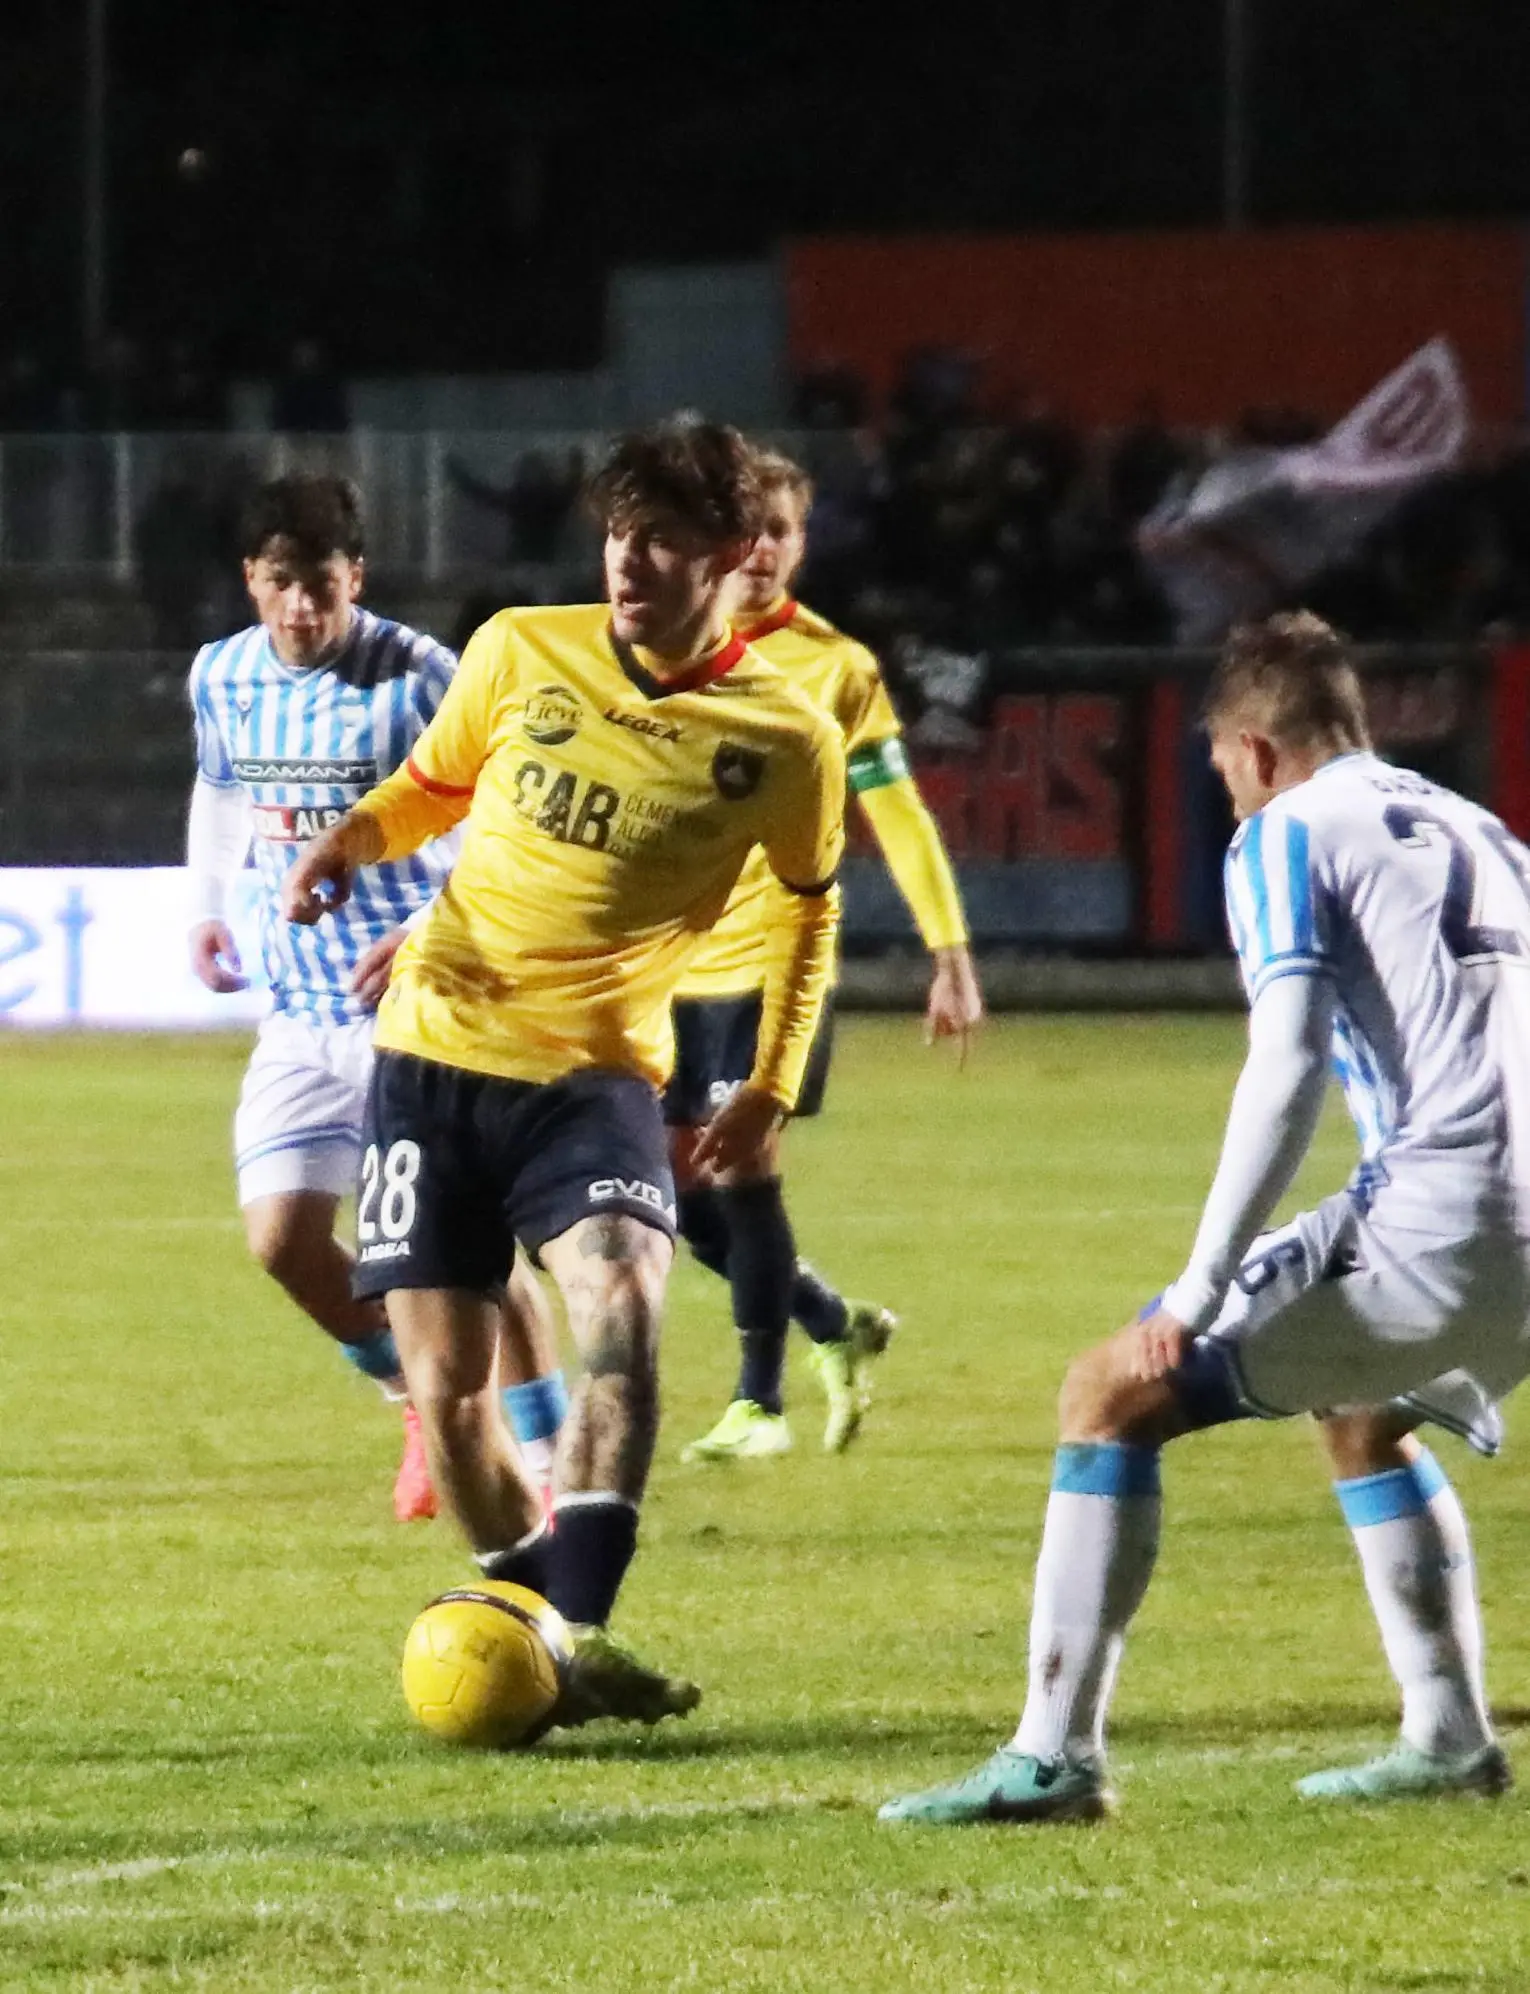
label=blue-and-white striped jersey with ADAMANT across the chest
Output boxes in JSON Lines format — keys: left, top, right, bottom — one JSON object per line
{"left": 190, "top": 608, "right": 457, "bottom": 1023}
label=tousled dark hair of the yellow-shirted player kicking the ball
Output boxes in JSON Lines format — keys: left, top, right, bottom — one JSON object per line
{"left": 584, "top": 417, "right": 764, "bottom": 542}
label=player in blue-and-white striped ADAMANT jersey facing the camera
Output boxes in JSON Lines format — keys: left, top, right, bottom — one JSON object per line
{"left": 188, "top": 477, "right": 563, "bottom": 1521}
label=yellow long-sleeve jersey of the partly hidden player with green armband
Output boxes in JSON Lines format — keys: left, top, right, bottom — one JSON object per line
{"left": 678, "top": 598, "right": 967, "bottom": 997}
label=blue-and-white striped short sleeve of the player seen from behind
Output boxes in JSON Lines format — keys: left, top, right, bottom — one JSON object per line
{"left": 1225, "top": 810, "right": 1333, "bottom": 1003}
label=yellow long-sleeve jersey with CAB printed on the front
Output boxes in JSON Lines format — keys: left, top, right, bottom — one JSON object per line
{"left": 357, "top": 604, "right": 846, "bottom": 1107}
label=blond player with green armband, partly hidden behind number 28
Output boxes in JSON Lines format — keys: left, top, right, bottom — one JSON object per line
{"left": 678, "top": 451, "right": 983, "bottom": 1462}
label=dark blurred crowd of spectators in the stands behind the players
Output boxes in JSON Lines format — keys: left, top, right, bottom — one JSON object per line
{"left": 0, "top": 337, "right": 1530, "bottom": 654}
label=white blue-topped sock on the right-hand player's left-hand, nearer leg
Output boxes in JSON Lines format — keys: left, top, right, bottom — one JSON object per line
{"left": 1013, "top": 1444, "right": 1163, "bottom": 1763}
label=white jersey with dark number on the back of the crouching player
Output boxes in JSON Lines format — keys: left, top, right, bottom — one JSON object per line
{"left": 1227, "top": 754, "right": 1530, "bottom": 1234}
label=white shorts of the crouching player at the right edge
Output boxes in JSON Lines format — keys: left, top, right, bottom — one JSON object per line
{"left": 1209, "top": 1192, "right": 1530, "bottom": 1452}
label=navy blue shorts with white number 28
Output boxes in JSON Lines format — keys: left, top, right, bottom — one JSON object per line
{"left": 353, "top": 1051, "right": 674, "bottom": 1300}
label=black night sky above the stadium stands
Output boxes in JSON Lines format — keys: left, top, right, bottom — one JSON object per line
{"left": 0, "top": 0, "right": 1530, "bottom": 371}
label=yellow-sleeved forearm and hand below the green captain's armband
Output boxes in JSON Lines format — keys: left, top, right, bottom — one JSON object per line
{"left": 850, "top": 749, "right": 983, "bottom": 1061}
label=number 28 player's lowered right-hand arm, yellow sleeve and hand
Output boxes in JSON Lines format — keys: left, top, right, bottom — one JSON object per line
{"left": 696, "top": 726, "right": 846, "bottom": 1170}
